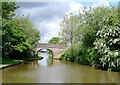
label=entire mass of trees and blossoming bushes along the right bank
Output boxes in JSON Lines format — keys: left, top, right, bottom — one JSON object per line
{"left": 60, "top": 6, "right": 120, "bottom": 71}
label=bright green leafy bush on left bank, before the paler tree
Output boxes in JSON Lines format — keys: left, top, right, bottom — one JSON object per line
{"left": 2, "top": 19, "right": 29, "bottom": 56}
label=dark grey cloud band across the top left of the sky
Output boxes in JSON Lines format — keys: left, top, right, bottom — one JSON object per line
{"left": 18, "top": 2, "right": 69, "bottom": 20}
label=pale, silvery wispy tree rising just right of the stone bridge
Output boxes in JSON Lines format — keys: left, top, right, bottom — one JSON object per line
{"left": 59, "top": 13, "right": 78, "bottom": 45}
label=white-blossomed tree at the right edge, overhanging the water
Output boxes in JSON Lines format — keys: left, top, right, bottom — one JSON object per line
{"left": 94, "top": 7, "right": 120, "bottom": 70}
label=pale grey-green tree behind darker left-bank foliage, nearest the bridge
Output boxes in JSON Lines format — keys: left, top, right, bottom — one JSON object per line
{"left": 16, "top": 16, "right": 40, "bottom": 50}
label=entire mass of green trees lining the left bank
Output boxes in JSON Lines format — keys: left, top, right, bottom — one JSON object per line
{"left": 2, "top": 2, "right": 40, "bottom": 58}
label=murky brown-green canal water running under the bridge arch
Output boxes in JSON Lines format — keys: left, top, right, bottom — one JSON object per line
{"left": 2, "top": 53, "right": 118, "bottom": 83}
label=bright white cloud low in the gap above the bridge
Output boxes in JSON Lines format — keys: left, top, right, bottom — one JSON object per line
{"left": 39, "top": 17, "right": 61, "bottom": 43}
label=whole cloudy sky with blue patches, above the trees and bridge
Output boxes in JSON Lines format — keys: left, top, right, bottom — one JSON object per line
{"left": 16, "top": 0, "right": 118, "bottom": 43}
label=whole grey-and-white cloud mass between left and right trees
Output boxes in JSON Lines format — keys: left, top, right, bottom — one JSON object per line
{"left": 15, "top": 2, "right": 69, "bottom": 43}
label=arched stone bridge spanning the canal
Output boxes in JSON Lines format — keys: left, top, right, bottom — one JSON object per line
{"left": 36, "top": 43, "right": 66, "bottom": 58}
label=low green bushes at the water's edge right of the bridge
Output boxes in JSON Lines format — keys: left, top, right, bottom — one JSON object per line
{"left": 59, "top": 45, "right": 101, "bottom": 66}
